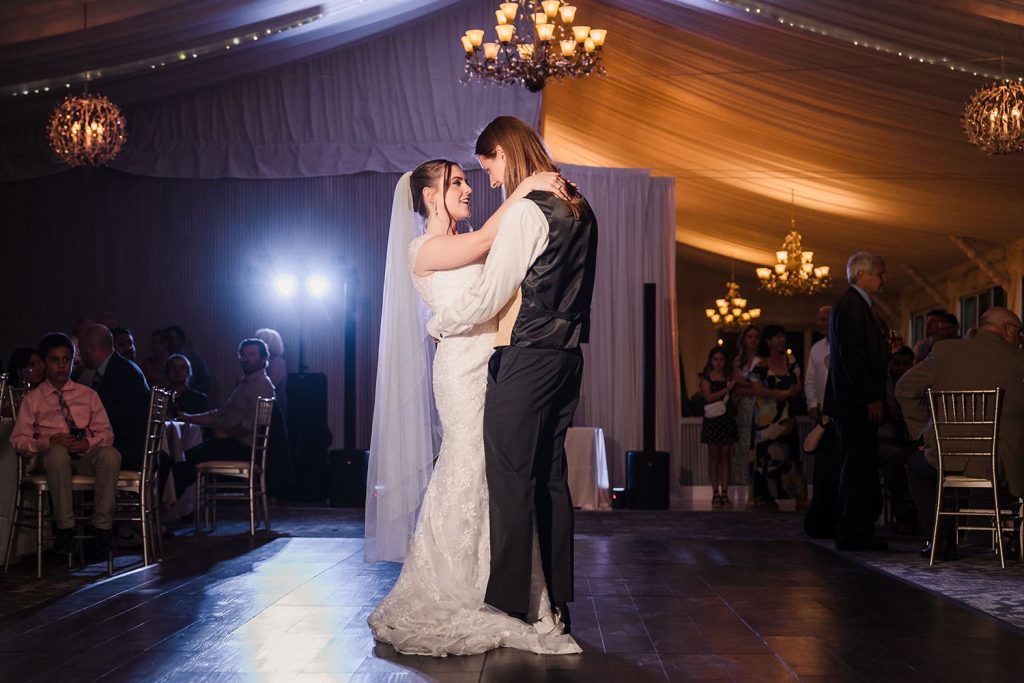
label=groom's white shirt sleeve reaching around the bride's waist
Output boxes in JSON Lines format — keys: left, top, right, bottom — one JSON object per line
{"left": 427, "top": 199, "right": 548, "bottom": 339}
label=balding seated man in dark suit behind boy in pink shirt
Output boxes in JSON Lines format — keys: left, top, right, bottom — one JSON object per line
{"left": 79, "top": 323, "right": 150, "bottom": 471}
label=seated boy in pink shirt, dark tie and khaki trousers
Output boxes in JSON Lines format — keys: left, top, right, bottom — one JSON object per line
{"left": 10, "top": 333, "right": 121, "bottom": 553}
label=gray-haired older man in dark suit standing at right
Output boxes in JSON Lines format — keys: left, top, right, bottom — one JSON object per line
{"left": 824, "top": 252, "right": 889, "bottom": 550}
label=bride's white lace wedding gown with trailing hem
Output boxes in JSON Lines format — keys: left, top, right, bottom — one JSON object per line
{"left": 367, "top": 234, "right": 582, "bottom": 656}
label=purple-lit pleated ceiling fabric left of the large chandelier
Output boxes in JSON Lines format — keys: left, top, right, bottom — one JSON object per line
{"left": 0, "top": 0, "right": 541, "bottom": 180}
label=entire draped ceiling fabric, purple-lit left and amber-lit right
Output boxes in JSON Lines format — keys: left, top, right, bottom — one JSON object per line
{"left": 6, "top": 0, "right": 1024, "bottom": 278}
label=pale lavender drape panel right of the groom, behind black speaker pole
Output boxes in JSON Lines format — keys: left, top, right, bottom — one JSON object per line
{"left": 561, "top": 165, "right": 681, "bottom": 485}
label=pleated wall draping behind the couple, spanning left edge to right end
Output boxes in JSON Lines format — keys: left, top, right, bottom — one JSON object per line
{"left": 0, "top": 166, "right": 680, "bottom": 497}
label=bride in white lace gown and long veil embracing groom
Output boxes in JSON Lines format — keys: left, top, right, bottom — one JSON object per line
{"left": 366, "top": 160, "right": 582, "bottom": 656}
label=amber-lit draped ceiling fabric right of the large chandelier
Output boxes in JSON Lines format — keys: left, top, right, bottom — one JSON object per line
{"left": 543, "top": 0, "right": 1024, "bottom": 290}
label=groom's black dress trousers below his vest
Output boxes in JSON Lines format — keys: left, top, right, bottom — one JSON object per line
{"left": 483, "top": 346, "right": 583, "bottom": 612}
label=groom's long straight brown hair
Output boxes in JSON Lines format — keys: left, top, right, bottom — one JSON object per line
{"left": 475, "top": 116, "right": 583, "bottom": 218}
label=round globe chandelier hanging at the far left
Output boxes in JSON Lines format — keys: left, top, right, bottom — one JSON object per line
{"left": 47, "top": 4, "right": 126, "bottom": 166}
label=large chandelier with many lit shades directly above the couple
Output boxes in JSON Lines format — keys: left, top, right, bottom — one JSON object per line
{"left": 462, "top": 0, "right": 608, "bottom": 92}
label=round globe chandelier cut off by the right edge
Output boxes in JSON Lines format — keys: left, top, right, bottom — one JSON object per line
{"left": 961, "top": 81, "right": 1024, "bottom": 155}
